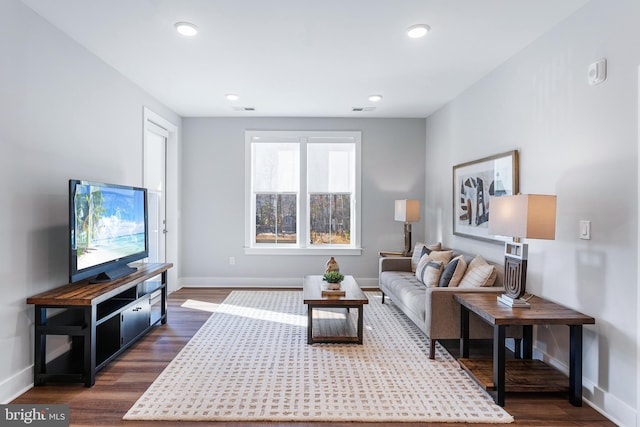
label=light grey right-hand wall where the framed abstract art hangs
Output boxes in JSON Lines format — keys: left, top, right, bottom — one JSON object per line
{"left": 425, "top": 0, "right": 640, "bottom": 425}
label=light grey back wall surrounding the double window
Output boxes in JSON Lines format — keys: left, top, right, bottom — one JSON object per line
{"left": 181, "top": 118, "right": 425, "bottom": 286}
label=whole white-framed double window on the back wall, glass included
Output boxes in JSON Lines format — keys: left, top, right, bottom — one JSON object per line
{"left": 246, "top": 131, "right": 361, "bottom": 254}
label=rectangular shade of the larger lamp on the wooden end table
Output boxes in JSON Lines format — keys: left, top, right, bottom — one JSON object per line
{"left": 489, "top": 194, "right": 556, "bottom": 240}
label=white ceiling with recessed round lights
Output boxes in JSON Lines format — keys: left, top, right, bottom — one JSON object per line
{"left": 22, "top": 0, "right": 588, "bottom": 117}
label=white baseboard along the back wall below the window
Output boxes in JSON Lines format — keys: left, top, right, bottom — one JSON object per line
{"left": 179, "top": 277, "right": 378, "bottom": 288}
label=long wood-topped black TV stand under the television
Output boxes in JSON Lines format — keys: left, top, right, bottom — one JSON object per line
{"left": 27, "top": 264, "right": 173, "bottom": 387}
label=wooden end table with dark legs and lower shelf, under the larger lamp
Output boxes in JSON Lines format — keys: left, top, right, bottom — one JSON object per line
{"left": 454, "top": 293, "right": 595, "bottom": 406}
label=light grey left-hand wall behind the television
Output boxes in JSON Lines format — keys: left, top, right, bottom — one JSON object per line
{"left": 0, "top": 0, "right": 180, "bottom": 402}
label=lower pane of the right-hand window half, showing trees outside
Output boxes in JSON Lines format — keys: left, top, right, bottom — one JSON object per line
{"left": 309, "top": 194, "right": 351, "bottom": 245}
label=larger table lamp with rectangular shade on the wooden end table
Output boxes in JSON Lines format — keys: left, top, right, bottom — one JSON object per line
{"left": 489, "top": 194, "right": 556, "bottom": 307}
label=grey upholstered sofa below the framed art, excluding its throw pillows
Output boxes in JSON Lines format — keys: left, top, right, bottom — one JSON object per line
{"left": 379, "top": 243, "right": 522, "bottom": 359}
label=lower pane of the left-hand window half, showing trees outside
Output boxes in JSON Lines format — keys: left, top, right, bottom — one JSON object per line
{"left": 256, "top": 193, "right": 298, "bottom": 244}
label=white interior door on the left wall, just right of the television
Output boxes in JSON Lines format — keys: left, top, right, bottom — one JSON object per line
{"left": 143, "top": 122, "right": 168, "bottom": 262}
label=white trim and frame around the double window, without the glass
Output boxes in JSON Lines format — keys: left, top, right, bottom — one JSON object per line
{"left": 244, "top": 130, "right": 362, "bottom": 256}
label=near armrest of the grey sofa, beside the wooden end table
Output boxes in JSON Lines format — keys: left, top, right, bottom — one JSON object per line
{"left": 425, "top": 286, "right": 504, "bottom": 340}
